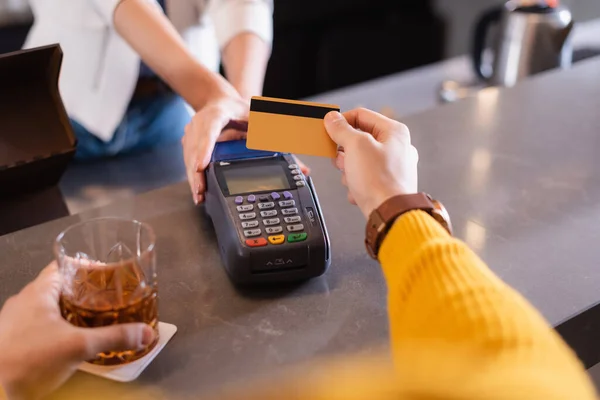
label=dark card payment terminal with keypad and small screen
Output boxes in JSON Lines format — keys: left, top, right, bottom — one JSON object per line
{"left": 206, "top": 140, "right": 331, "bottom": 285}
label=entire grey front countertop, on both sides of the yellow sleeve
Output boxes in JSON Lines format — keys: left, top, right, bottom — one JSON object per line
{"left": 0, "top": 59, "right": 600, "bottom": 396}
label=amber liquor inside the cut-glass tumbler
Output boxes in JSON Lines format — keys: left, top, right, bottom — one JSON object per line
{"left": 60, "top": 265, "right": 158, "bottom": 365}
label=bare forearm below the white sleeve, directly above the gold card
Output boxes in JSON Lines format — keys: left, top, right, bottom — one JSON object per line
{"left": 223, "top": 32, "right": 271, "bottom": 99}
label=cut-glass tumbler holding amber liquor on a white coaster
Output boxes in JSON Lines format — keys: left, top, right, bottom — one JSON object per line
{"left": 55, "top": 218, "right": 158, "bottom": 365}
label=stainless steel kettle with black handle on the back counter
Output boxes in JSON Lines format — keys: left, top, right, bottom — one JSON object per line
{"left": 473, "top": 0, "right": 574, "bottom": 86}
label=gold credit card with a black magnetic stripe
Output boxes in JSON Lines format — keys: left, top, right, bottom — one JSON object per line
{"left": 246, "top": 97, "right": 340, "bottom": 158}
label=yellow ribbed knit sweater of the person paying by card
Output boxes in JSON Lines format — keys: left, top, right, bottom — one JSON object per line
{"left": 211, "top": 211, "right": 596, "bottom": 400}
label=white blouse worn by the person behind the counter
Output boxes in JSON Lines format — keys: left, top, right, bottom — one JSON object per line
{"left": 24, "top": 0, "right": 273, "bottom": 142}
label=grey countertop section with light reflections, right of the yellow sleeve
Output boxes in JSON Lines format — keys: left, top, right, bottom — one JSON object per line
{"left": 406, "top": 59, "right": 600, "bottom": 366}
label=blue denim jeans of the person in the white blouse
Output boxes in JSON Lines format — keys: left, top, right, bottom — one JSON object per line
{"left": 71, "top": 94, "right": 191, "bottom": 161}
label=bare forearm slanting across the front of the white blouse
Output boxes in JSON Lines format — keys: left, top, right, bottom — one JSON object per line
{"left": 114, "top": 0, "right": 234, "bottom": 110}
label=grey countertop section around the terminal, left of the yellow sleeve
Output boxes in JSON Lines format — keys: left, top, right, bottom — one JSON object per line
{"left": 0, "top": 166, "right": 387, "bottom": 396}
